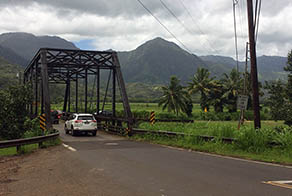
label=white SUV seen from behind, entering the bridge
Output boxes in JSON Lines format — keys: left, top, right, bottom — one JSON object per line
{"left": 64, "top": 114, "right": 97, "bottom": 136}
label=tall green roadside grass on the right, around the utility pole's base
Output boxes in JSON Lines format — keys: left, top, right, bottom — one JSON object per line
{"left": 134, "top": 121, "right": 292, "bottom": 164}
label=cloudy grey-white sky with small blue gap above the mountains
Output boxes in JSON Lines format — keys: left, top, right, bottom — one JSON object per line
{"left": 0, "top": 0, "right": 292, "bottom": 60}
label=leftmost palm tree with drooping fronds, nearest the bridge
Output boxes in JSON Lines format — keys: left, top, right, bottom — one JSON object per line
{"left": 158, "top": 76, "right": 190, "bottom": 116}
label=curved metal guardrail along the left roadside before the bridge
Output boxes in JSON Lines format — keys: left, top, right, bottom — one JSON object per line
{"left": 0, "top": 132, "right": 59, "bottom": 153}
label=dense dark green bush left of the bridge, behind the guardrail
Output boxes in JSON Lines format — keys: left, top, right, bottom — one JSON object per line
{"left": 0, "top": 85, "right": 32, "bottom": 139}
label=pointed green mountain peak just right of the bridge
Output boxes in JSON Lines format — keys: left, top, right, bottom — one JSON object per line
{"left": 118, "top": 38, "right": 206, "bottom": 84}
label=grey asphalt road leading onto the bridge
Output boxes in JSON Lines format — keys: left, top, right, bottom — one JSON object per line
{"left": 56, "top": 124, "right": 292, "bottom": 196}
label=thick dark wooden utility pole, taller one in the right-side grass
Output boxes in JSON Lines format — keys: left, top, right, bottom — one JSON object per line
{"left": 247, "top": 0, "right": 261, "bottom": 129}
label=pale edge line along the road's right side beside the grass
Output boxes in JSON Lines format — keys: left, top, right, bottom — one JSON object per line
{"left": 161, "top": 145, "right": 292, "bottom": 169}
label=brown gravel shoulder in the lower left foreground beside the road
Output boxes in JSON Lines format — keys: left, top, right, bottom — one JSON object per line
{"left": 0, "top": 145, "right": 138, "bottom": 196}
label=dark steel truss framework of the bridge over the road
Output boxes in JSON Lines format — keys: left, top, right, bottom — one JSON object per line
{"left": 24, "top": 48, "right": 133, "bottom": 129}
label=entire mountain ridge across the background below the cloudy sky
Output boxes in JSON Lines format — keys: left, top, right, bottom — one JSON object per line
{"left": 0, "top": 32, "right": 287, "bottom": 84}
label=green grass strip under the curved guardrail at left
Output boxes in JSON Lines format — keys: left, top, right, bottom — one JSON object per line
{"left": 0, "top": 138, "right": 61, "bottom": 157}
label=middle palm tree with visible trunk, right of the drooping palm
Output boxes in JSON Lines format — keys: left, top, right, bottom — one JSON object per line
{"left": 187, "top": 68, "right": 215, "bottom": 110}
